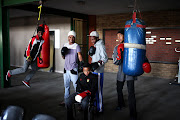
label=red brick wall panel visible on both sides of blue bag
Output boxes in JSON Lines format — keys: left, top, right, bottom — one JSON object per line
{"left": 103, "top": 28, "right": 180, "bottom": 63}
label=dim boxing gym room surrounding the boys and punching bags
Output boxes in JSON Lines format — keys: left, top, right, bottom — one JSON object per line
{"left": 0, "top": 0, "right": 180, "bottom": 120}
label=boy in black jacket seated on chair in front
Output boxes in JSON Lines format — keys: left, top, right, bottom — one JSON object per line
{"left": 66, "top": 63, "right": 98, "bottom": 120}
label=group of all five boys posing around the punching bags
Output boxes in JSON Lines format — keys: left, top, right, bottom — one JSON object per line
{"left": 6, "top": 27, "right": 137, "bottom": 120}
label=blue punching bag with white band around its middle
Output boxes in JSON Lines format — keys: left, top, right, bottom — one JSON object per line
{"left": 123, "top": 12, "right": 146, "bottom": 76}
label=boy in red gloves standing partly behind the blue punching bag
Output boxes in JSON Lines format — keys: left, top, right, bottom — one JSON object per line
{"left": 112, "top": 29, "right": 137, "bottom": 120}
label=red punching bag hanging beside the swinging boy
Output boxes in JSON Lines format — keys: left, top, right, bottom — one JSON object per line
{"left": 37, "top": 24, "right": 50, "bottom": 68}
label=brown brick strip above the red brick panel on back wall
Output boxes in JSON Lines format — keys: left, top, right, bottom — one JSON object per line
{"left": 96, "top": 9, "right": 180, "bottom": 39}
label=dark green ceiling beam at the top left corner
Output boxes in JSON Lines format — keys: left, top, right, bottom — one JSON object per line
{"left": 3, "top": 0, "right": 39, "bottom": 6}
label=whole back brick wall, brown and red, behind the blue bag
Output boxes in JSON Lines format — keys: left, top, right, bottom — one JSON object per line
{"left": 96, "top": 10, "right": 180, "bottom": 78}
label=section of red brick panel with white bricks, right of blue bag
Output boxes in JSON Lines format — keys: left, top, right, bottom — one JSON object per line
{"left": 146, "top": 28, "right": 180, "bottom": 63}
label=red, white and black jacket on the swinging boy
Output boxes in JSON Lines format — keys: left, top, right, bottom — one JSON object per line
{"left": 24, "top": 35, "right": 44, "bottom": 61}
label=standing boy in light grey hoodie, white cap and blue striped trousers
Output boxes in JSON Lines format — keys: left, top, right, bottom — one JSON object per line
{"left": 88, "top": 31, "right": 108, "bottom": 112}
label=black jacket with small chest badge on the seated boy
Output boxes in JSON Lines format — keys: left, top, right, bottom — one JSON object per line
{"left": 76, "top": 73, "right": 98, "bottom": 97}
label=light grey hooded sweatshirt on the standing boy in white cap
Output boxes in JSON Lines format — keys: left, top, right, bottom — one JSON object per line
{"left": 91, "top": 40, "right": 108, "bottom": 73}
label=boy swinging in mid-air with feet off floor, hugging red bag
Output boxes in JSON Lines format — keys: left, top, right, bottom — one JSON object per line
{"left": 6, "top": 26, "right": 44, "bottom": 88}
